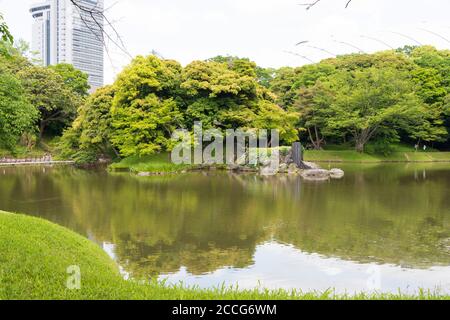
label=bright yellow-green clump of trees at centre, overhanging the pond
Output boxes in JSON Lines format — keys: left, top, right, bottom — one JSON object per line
{"left": 61, "top": 56, "right": 298, "bottom": 162}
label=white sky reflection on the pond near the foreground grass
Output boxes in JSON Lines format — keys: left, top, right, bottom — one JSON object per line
{"left": 137, "top": 242, "right": 450, "bottom": 293}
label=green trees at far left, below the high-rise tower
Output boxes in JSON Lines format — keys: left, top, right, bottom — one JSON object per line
{"left": 0, "top": 41, "right": 89, "bottom": 154}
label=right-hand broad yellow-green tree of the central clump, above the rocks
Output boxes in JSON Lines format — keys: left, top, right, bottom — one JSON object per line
{"left": 181, "top": 57, "right": 298, "bottom": 142}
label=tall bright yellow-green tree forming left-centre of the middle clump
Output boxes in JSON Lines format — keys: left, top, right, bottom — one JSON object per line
{"left": 111, "top": 56, "right": 183, "bottom": 156}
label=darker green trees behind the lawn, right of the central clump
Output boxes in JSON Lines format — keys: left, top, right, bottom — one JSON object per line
{"left": 270, "top": 46, "right": 450, "bottom": 152}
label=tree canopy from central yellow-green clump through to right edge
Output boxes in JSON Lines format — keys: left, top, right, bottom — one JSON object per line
{"left": 52, "top": 47, "right": 450, "bottom": 162}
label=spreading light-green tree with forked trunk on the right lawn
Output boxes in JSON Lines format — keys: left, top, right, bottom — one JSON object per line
{"left": 327, "top": 67, "right": 444, "bottom": 152}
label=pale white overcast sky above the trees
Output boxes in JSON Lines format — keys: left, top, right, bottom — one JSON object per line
{"left": 0, "top": 0, "right": 450, "bottom": 83}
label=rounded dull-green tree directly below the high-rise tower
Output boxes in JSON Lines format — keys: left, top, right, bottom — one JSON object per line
{"left": 18, "top": 66, "right": 81, "bottom": 138}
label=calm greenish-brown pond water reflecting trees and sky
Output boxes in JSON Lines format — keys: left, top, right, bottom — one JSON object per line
{"left": 0, "top": 164, "right": 450, "bottom": 293}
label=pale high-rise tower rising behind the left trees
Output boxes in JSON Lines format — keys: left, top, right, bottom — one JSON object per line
{"left": 30, "top": 0, "right": 103, "bottom": 90}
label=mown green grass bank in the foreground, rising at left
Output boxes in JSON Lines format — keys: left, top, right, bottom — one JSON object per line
{"left": 0, "top": 211, "right": 450, "bottom": 300}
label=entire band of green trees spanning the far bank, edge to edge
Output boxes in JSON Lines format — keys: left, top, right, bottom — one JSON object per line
{"left": 0, "top": 38, "right": 450, "bottom": 162}
